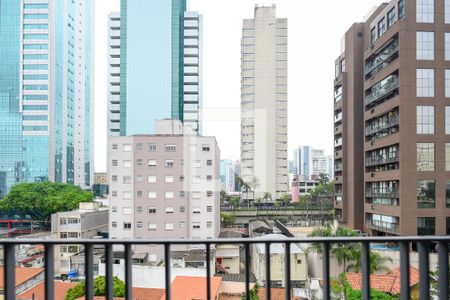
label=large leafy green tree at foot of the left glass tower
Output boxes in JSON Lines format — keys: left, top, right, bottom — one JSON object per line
{"left": 0, "top": 182, "right": 93, "bottom": 221}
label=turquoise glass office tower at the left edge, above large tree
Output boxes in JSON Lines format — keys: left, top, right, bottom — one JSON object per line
{"left": 0, "top": 0, "right": 94, "bottom": 198}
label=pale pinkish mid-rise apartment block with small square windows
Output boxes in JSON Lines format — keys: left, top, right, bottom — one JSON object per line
{"left": 108, "top": 120, "right": 220, "bottom": 258}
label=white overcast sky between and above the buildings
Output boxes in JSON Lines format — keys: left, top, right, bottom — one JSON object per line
{"left": 94, "top": 0, "right": 383, "bottom": 172}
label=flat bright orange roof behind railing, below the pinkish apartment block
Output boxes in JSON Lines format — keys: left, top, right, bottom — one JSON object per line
{"left": 162, "top": 276, "right": 222, "bottom": 300}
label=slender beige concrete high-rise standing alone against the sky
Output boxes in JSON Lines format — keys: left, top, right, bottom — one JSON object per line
{"left": 241, "top": 5, "right": 288, "bottom": 200}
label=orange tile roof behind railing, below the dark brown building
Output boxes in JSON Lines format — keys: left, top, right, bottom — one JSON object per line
{"left": 346, "top": 267, "right": 419, "bottom": 295}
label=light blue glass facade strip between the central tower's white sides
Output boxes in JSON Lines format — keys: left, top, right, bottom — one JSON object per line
{"left": 120, "top": 0, "right": 186, "bottom": 135}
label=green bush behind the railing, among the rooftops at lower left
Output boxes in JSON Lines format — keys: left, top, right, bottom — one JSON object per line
{"left": 64, "top": 276, "right": 125, "bottom": 300}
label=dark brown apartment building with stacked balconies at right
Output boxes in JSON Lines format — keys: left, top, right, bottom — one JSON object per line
{"left": 334, "top": 0, "right": 450, "bottom": 235}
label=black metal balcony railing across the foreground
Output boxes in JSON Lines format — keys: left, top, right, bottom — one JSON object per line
{"left": 0, "top": 237, "right": 450, "bottom": 300}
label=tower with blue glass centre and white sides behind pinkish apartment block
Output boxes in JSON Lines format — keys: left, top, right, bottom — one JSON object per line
{"left": 108, "top": 0, "right": 202, "bottom": 136}
